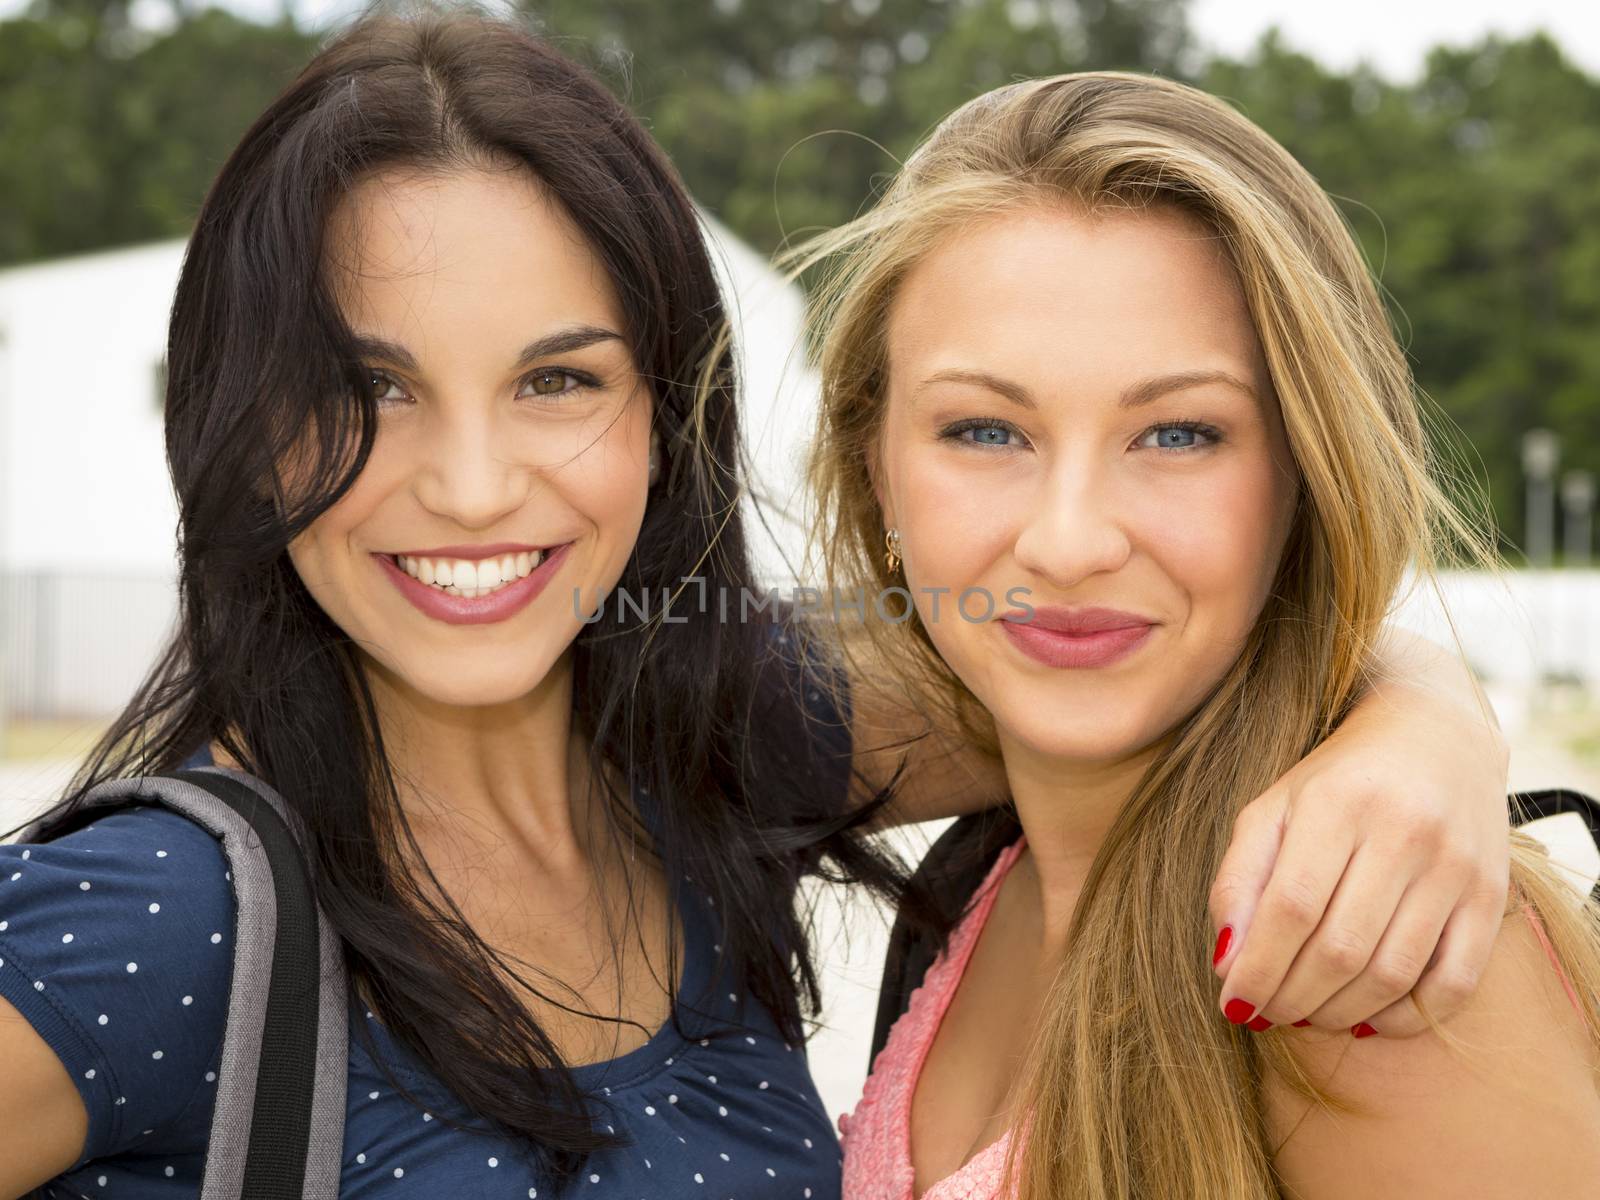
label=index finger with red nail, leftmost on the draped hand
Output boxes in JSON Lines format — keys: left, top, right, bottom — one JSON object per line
{"left": 1219, "top": 803, "right": 1357, "bottom": 1026}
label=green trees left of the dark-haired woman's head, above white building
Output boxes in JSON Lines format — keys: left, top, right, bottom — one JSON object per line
{"left": 0, "top": 0, "right": 317, "bottom": 262}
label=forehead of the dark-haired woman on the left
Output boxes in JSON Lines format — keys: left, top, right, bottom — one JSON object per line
{"left": 328, "top": 170, "right": 621, "bottom": 331}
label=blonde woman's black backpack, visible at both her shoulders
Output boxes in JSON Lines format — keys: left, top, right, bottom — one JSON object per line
{"left": 867, "top": 787, "right": 1600, "bottom": 1070}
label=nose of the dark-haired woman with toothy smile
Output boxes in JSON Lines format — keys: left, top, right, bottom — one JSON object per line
{"left": 414, "top": 403, "right": 534, "bottom": 530}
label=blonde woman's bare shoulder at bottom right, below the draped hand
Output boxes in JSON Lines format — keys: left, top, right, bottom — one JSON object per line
{"left": 1262, "top": 909, "right": 1600, "bottom": 1200}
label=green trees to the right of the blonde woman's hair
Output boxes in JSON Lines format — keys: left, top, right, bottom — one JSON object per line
{"left": 1198, "top": 34, "right": 1600, "bottom": 549}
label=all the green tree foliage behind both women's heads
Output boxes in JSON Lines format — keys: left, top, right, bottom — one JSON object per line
{"left": 0, "top": 0, "right": 1600, "bottom": 550}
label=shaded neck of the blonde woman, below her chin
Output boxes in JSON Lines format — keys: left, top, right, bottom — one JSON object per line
{"left": 1000, "top": 731, "right": 1160, "bottom": 950}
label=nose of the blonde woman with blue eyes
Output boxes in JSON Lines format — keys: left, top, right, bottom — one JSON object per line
{"left": 1013, "top": 454, "right": 1133, "bottom": 590}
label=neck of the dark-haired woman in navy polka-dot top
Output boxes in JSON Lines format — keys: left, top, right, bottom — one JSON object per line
{"left": 368, "top": 654, "right": 603, "bottom": 870}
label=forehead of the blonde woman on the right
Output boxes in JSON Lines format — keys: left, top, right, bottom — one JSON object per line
{"left": 888, "top": 205, "right": 1259, "bottom": 395}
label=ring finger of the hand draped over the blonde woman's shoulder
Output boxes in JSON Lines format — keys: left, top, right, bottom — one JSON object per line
{"left": 1285, "top": 854, "right": 1461, "bottom": 1032}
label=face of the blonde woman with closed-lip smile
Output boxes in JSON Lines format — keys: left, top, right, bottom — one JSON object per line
{"left": 875, "top": 206, "right": 1296, "bottom": 763}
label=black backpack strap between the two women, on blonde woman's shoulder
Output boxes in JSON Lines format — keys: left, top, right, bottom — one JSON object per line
{"left": 869, "top": 810, "right": 1022, "bottom": 1067}
